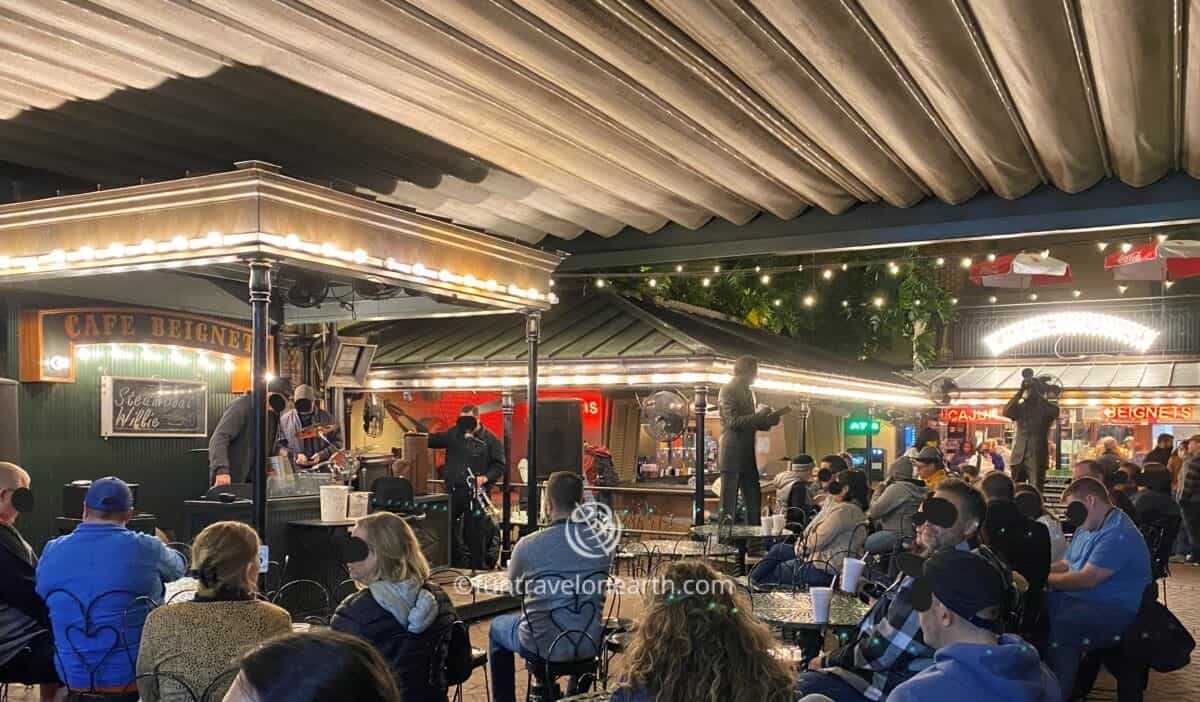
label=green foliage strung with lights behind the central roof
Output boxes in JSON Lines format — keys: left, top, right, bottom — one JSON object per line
{"left": 611, "top": 250, "right": 954, "bottom": 370}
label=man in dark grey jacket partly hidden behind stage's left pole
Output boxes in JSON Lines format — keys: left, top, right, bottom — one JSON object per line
{"left": 209, "top": 378, "right": 288, "bottom": 486}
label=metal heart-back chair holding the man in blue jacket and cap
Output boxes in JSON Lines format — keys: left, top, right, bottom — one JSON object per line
{"left": 44, "top": 588, "right": 157, "bottom": 702}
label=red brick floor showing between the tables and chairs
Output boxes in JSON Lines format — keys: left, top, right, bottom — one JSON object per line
{"left": 10, "top": 564, "right": 1200, "bottom": 702}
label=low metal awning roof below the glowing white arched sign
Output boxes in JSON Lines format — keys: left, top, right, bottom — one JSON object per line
{"left": 913, "top": 361, "right": 1200, "bottom": 394}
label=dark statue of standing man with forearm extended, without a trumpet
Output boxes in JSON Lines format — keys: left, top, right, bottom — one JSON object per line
{"left": 716, "top": 356, "right": 786, "bottom": 524}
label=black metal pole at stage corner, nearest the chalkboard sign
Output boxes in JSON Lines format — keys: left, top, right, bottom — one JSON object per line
{"left": 250, "top": 260, "right": 271, "bottom": 544}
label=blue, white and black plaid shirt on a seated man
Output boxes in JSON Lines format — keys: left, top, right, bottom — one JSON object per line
{"left": 822, "top": 544, "right": 1008, "bottom": 702}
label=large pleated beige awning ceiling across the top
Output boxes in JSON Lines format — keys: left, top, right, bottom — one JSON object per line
{"left": 0, "top": 0, "right": 1185, "bottom": 241}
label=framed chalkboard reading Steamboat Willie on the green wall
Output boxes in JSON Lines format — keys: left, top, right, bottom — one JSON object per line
{"left": 100, "top": 376, "right": 209, "bottom": 437}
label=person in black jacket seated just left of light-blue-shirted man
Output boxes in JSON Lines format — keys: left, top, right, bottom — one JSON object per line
{"left": 982, "top": 472, "right": 1050, "bottom": 638}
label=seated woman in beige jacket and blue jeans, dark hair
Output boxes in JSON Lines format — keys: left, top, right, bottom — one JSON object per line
{"left": 750, "top": 470, "right": 868, "bottom": 586}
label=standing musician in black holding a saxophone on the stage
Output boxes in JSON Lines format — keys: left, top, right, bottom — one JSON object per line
{"left": 430, "top": 404, "right": 508, "bottom": 570}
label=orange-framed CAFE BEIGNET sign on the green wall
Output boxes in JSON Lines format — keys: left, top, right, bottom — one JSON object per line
{"left": 20, "top": 307, "right": 252, "bottom": 383}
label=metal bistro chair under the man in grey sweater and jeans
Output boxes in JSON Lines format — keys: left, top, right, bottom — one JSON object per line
{"left": 521, "top": 570, "right": 608, "bottom": 702}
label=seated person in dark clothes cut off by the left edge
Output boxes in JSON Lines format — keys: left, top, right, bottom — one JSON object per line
{"left": 0, "top": 462, "right": 60, "bottom": 701}
